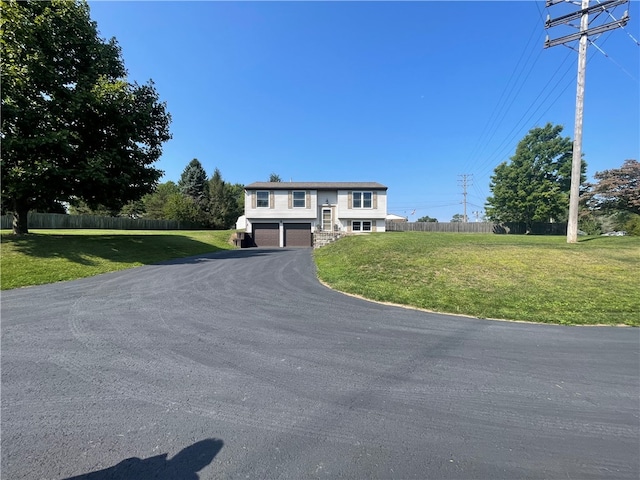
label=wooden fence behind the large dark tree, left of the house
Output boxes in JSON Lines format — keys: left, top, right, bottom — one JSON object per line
{"left": 0, "top": 212, "right": 200, "bottom": 230}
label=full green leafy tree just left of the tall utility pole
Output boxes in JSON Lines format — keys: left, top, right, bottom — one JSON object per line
{"left": 486, "top": 123, "right": 586, "bottom": 227}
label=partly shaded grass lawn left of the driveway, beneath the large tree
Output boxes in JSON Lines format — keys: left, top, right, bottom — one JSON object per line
{"left": 0, "top": 230, "right": 233, "bottom": 290}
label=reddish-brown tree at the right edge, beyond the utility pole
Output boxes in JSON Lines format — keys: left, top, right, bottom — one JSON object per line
{"left": 587, "top": 160, "right": 640, "bottom": 215}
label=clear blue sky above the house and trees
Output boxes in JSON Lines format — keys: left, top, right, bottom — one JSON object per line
{"left": 90, "top": 1, "right": 640, "bottom": 221}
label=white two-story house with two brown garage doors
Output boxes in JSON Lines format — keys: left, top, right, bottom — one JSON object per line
{"left": 244, "top": 182, "right": 387, "bottom": 247}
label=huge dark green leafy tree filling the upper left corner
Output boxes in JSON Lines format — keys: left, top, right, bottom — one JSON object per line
{"left": 0, "top": 0, "right": 170, "bottom": 234}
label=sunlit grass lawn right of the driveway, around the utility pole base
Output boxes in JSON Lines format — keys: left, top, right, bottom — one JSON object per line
{"left": 314, "top": 232, "right": 640, "bottom": 326}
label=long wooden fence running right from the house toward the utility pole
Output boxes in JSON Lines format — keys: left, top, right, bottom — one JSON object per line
{"left": 385, "top": 221, "right": 567, "bottom": 235}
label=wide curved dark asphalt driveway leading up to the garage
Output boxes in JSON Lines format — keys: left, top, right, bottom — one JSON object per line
{"left": 1, "top": 249, "right": 640, "bottom": 480}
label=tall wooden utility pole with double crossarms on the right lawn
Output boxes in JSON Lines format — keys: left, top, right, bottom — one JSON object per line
{"left": 544, "top": 0, "right": 629, "bottom": 243}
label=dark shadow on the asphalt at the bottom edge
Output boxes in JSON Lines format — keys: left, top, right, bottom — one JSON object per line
{"left": 66, "top": 438, "right": 224, "bottom": 480}
